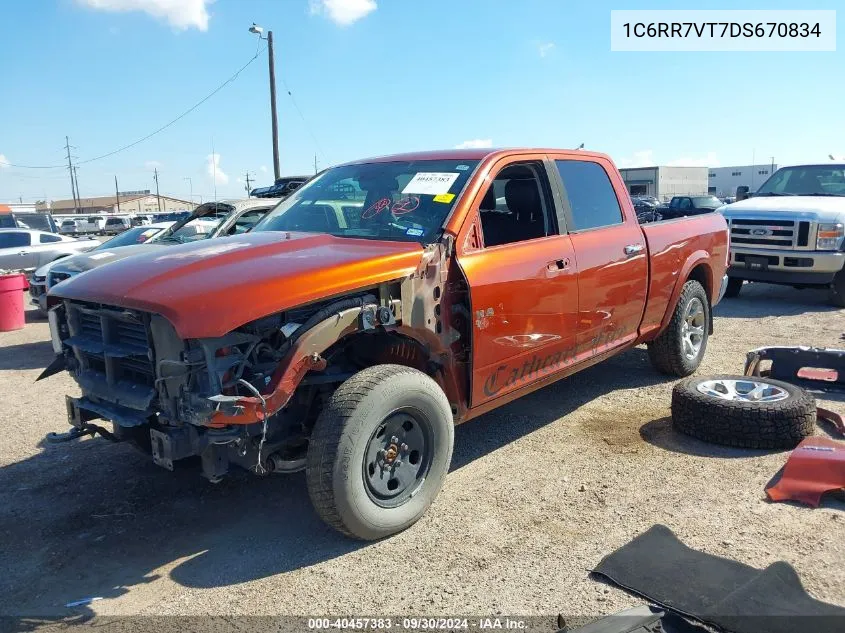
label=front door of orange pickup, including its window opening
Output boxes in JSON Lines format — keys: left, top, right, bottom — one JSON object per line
{"left": 458, "top": 155, "right": 578, "bottom": 406}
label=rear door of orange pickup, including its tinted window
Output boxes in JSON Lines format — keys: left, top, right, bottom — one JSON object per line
{"left": 555, "top": 157, "right": 648, "bottom": 358}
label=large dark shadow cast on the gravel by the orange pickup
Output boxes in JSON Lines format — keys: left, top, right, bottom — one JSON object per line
{"left": 0, "top": 343, "right": 667, "bottom": 617}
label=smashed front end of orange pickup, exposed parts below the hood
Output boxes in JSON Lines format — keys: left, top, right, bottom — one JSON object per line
{"left": 39, "top": 240, "right": 469, "bottom": 482}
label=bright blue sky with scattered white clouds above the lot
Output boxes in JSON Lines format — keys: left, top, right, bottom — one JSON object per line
{"left": 0, "top": 0, "right": 845, "bottom": 201}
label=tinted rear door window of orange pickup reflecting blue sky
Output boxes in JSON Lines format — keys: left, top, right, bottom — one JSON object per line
{"left": 555, "top": 160, "right": 622, "bottom": 231}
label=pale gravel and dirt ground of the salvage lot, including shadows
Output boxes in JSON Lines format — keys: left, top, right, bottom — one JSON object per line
{"left": 0, "top": 285, "right": 845, "bottom": 616}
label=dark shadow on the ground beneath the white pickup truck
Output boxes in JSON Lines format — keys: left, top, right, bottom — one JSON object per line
{"left": 713, "top": 283, "right": 841, "bottom": 318}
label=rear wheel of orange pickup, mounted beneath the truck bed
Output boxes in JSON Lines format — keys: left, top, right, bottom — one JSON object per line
{"left": 648, "top": 280, "right": 710, "bottom": 376}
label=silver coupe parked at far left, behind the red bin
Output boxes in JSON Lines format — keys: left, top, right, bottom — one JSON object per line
{"left": 0, "top": 229, "right": 97, "bottom": 270}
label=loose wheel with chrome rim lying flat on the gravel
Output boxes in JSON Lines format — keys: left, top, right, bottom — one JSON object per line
{"left": 672, "top": 376, "right": 816, "bottom": 449}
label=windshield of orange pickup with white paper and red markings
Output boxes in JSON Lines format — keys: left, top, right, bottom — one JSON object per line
{"left": 253, "top": 160, "right": 478, "bottom": 244}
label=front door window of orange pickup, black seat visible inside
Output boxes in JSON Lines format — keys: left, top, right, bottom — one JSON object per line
{"left": 479, "top": 162, "right": 557, "bottom": 246}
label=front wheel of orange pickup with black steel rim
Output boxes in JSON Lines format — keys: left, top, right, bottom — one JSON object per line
{"left": 305, "top": 365, "right": 455, "bottom": 540}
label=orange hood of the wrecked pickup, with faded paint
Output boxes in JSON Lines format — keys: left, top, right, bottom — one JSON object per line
{"left": 51, "top": 231, "right": 423, "bottom": 339}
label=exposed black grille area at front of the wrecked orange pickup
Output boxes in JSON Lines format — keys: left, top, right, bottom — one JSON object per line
{"left": 64, "top": 301, "right": 156, "bottom": 410}
